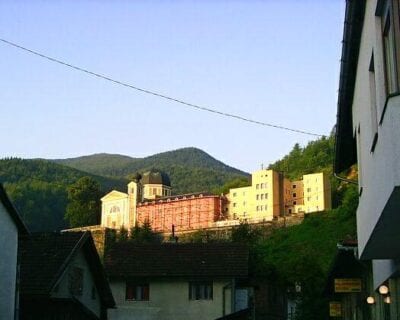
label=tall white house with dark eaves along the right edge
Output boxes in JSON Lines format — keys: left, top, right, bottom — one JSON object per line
{"left": 335, "top": 0, "right": 400, "bottom": 319}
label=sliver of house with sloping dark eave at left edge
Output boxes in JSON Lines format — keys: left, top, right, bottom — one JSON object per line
{"left": 0, "top": 184, "right": 28, "bottom": 319}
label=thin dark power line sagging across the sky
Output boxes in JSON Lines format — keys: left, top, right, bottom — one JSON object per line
{"left": 0, "top": 38, "right": 323, "bottom": 137}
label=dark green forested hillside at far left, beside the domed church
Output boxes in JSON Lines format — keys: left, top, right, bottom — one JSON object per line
{"left": 0, "top": 158, "right": 126, "bottom": 231}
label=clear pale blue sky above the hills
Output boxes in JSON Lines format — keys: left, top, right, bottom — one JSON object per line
{"left": 0, "top": 0, "right": 345, "bottom": 171}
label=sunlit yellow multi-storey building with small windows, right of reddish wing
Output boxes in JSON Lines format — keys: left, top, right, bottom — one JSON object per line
{"left": 227, "top": 169, "right": 331, "bottom": 223}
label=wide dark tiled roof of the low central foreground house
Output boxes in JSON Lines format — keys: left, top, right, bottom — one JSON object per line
{"left": 105, "top": 242, "right": 249, "bottom": 278}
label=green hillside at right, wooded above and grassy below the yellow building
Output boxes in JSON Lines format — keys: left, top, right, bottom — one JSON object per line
{"left": 252, "top": 136, "right": 358, "bottom": 320}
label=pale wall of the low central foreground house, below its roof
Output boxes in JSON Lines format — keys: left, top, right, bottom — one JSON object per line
{"left": 108, "top": 280, "right": 231, "bottom": 320}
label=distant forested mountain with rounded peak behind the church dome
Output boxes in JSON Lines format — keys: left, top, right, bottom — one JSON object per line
{"left": 55, "top": 148, "right": 248, "bottom": 194}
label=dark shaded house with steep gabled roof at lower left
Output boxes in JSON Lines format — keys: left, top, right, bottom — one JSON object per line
{"left": 19, "top": 232, "right": 115, "bottom": 320}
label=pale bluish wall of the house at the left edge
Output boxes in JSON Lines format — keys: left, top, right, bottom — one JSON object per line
{"left": 0, "top": 202, "right": 18, "bottom": 320}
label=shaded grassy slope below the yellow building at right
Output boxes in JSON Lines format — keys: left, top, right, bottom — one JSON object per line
{"left": 252, "top": 184, "right": 358, "bottom": 320}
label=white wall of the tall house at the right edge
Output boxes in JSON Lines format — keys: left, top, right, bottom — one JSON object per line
{"left": 353, "top": 0, "right": 400, "bottom": 259}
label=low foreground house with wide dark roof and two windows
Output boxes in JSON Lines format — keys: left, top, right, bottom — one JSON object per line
{"left": 105, "top": 242, "right": 251, "bottom": 320}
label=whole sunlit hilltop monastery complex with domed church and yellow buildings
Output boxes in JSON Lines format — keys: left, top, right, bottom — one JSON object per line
{"left": 101, "top": 169, "right": 331, "bottom": 232}
